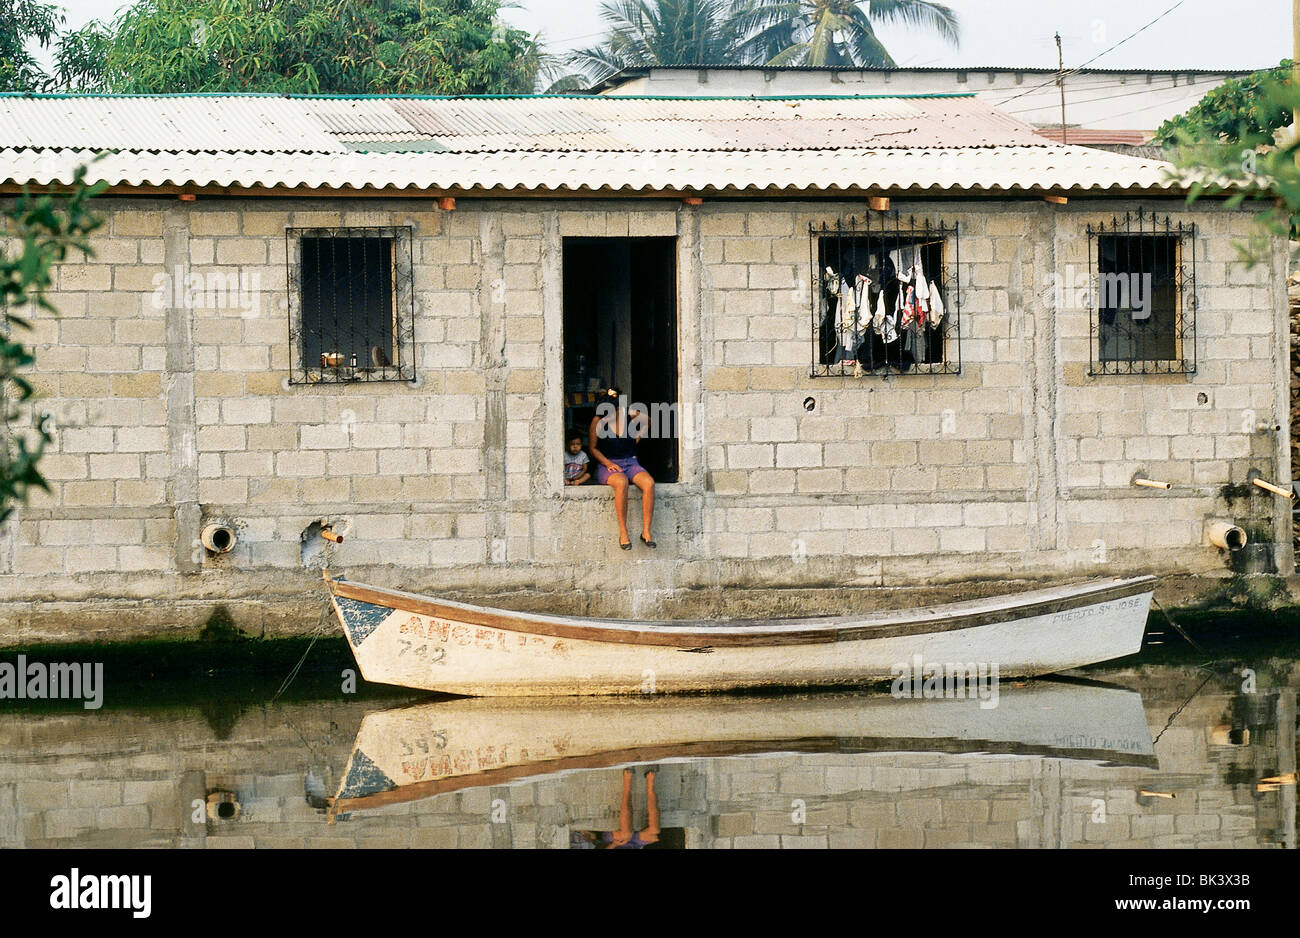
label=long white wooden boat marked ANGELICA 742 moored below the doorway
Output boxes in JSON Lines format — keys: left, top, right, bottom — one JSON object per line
{"left": 326, "top": 577, "right": 1156, "bottom": 696}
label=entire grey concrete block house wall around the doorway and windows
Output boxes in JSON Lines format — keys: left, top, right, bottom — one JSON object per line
{"left": 0, "top": 197, "right": 1292, "bottom": 643}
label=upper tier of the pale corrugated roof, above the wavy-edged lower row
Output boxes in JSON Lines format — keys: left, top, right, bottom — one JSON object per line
{"left": 0, "top": 95, "right": 1041, "bottom": 153}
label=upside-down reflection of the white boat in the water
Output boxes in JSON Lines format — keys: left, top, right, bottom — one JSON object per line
{"left": 330, "top": 681, "right": 1158, "bottom": 821}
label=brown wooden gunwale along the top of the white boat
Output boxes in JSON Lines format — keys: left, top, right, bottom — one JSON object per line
{"left": 329, "top": 576, "right": 1157, "bottom": 651}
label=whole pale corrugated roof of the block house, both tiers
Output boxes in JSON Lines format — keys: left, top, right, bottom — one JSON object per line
{"left": 0, "top": 95, "right": 1178, "bottom": 192}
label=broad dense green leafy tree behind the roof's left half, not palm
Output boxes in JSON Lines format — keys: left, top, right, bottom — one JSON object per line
{"left": 56, "top": 0, "right": 542, "bottom": 95}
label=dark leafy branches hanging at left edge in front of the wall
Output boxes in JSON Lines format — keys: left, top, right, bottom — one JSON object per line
{"left": 0, "top": 168, "right": 103, "bottom": 522}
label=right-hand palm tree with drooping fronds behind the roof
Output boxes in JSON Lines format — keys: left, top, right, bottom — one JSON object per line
{"left": 731, "top": 0, "right": 958, "bottom": 68}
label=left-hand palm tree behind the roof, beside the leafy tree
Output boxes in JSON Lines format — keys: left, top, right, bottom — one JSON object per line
{"left": 553, "top": 0, "right": 741, "bottom": 90}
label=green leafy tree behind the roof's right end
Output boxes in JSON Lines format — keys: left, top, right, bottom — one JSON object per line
{"left": 1153, "top": 58, "right": 1291, "bottom": 146}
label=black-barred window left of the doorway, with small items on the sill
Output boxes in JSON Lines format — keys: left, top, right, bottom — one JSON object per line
{"left": 285, "top": 227, "right": 415, "bottom": 385}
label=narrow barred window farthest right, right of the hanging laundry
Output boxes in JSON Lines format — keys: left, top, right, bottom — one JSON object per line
{"left": 1088, "top": 212, "right": 1196, "bottom": 374}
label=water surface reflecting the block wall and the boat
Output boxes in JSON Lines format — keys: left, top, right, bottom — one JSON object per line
{"left": 0, "top": 663, "right": 1300, "bottom": 848}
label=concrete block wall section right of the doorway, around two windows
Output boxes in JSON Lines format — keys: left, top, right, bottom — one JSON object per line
{"left": 701, "top": 201, "right": 1290, "bottom": 581}
